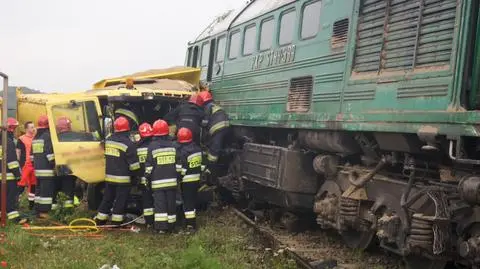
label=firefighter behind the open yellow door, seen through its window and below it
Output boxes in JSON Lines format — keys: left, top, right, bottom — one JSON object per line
{"left": 52, "top": 116, "right": 76, "bottom": 209}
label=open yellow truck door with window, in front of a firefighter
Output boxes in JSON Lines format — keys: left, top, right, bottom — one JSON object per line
{"left": 47, "top": 97, "right": 105, "bottom": 183}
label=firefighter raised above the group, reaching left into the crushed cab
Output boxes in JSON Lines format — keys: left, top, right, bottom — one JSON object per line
{"left": 164, "top": 94, "right": 205, "bottom": 143}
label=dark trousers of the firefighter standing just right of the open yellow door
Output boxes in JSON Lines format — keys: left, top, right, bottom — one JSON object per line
{"left": 96, "top": 183, "right": 132, "bottom": 225}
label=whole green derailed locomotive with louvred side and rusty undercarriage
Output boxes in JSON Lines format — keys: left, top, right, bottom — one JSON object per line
{"left": 186, "top": 0, "right": 480, "bottom": 268}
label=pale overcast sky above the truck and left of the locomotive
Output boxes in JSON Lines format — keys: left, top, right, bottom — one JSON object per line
{"left": 0, "top": 0, "right": 240, "bottom": 92}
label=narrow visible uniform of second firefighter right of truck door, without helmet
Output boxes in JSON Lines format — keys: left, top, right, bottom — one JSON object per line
{"left": 137, "top": 137, "right": 154, "bottom": 225}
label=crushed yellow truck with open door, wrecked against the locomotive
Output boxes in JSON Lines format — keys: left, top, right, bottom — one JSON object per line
{"left": 11, "top": 68, "right": 200, "bottom": 209}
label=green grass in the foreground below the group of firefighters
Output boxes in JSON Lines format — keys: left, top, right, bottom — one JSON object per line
{"left": 0, "top": 195, "right": 296, "bottom": 269}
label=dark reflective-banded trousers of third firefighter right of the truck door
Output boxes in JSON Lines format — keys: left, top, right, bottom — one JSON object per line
{"left": 153, "top": 187, "right": 177, "bottom": 232}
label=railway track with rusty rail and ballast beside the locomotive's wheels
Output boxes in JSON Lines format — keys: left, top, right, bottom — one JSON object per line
{"left": 232, "top": 208, "right": 403, "bottom": 269}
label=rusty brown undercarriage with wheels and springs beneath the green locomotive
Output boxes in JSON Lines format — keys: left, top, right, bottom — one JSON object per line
{"left": 219, "top": 126, "right": 480, "bottom": 269}
